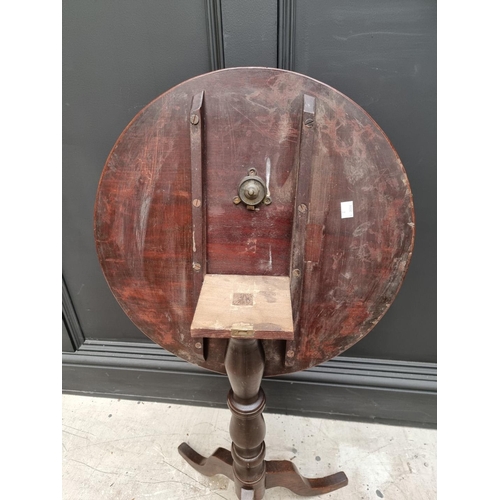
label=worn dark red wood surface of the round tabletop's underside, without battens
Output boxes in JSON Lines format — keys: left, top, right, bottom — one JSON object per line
{"left": 95, "top": 68, "right": 415, "bottom": 376}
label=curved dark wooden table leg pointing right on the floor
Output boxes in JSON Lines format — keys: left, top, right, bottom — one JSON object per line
{"left": 266, "top": 460, "right": 348, "bottom": 497}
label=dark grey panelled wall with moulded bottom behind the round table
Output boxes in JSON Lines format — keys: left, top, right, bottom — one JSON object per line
{"left": 62, "top": 0, "right": 436, "bottom": 421}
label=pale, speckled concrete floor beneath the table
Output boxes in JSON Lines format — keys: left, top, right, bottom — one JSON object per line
{"left": 62, "top": 395, "right": 436, "bottom": 500}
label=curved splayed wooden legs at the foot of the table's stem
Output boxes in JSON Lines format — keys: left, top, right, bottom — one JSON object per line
{"left": 178, "top": 443, "right": 347, "bottom": 500}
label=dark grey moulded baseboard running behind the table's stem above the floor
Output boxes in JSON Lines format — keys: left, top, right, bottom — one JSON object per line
{"left": 62, "top": 340, "right": 437, "bottom": 427}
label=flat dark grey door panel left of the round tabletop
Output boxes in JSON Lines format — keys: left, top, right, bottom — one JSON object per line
{"left": 63, "top": 0, "right": 210, "bottom": 342}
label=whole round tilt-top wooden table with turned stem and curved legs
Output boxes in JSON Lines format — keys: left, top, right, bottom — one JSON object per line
{"left": 95, "top": 68, "right": 415, "bottom": 499}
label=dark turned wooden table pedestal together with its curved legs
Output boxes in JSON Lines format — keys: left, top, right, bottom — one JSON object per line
{"left": 179, "top": 338, "right": 347, "bottom": 500}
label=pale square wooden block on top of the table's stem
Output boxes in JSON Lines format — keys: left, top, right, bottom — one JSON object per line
{"left": 191, "top": 274, "right": 293, "bottom": 340}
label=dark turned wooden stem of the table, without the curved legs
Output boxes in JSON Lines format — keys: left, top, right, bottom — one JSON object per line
{"left": 225, "top": 338, "right": 266, "bottom": 500}
